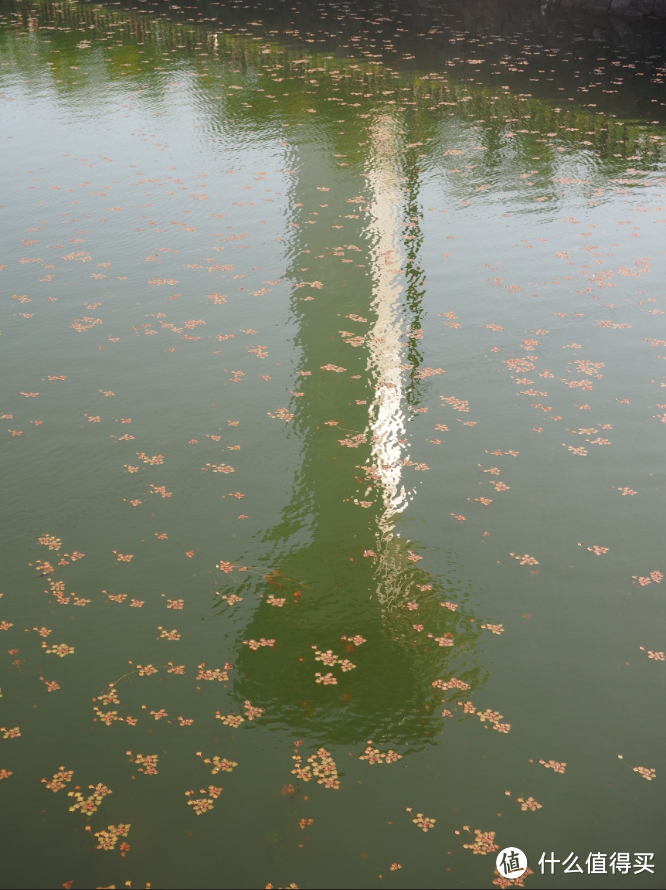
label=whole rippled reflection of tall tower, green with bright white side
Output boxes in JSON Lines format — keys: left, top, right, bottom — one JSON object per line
{"left": 220, "top": 128, "right": 486, "bottom": 744}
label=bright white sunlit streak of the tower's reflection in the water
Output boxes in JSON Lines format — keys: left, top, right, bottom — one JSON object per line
{"left": 368, "top": 120, "right": 408, "bottom": 540}
